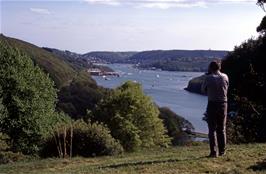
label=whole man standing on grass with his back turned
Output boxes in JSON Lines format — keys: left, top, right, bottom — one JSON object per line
{"left": 202, "top": 61, "right": 229, "bottom": 157}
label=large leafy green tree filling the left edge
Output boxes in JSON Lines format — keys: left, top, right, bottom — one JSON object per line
{"left": 0, "top": 39, "right": 57, "bottom": 154}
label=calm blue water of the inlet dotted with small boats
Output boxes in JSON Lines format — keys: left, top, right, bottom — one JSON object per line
{"left": 93, "top": 64, "right": 207, "bottom": 133}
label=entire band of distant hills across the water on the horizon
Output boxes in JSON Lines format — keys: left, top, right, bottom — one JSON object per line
{"left": 82, "top": 50, "right": 228, "bottom": 71}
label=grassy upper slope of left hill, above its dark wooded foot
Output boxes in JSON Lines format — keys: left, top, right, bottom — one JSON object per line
{"left": 0, "top": 34, "right": 76, "bottom": 88}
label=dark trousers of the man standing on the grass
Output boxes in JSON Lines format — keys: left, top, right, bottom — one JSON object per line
{"left": 207, "top": 101, "right": 227, "bottom": 155}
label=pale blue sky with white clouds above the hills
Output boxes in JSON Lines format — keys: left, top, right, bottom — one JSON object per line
{"left": 0, "top": 0, "right": 265, "bottom": 53}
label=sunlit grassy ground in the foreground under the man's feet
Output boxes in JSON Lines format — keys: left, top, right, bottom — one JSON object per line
{"left": 0, "top": 144, "right": 266, "bottom": 174}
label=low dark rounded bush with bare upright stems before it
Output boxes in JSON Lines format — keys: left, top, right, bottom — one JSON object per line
{"left": 40, "top": 120, "right": 123, "bottom": 157}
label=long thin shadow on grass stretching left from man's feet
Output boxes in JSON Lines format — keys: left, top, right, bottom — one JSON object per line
{"left": 99, "top": 156, "right": 206, "bottom": 168}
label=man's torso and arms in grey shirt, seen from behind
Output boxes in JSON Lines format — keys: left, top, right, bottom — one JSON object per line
{"left": 202, "top": 72, "right": 229, "bottom": 102}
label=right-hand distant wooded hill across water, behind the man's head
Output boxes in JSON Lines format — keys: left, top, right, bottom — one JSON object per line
{"left": 130, "top": 50, "right": 228, "bottom": 72}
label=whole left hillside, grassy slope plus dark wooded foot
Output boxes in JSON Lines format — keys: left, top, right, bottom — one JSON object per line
{"left": 0, "top": 34, "right": 105, "bottom": 118}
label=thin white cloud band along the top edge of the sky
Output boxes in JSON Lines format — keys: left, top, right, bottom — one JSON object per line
{"left": 84, "top": 0, "right": 256, "bottom": 9}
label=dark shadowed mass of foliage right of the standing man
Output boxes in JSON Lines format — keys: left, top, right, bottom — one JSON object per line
{"left": 222, "top": 36, "right": 266, "bottom": 142}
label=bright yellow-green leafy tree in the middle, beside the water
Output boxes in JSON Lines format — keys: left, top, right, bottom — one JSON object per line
{"left": 90, "top": 82, "right": 169, "bottom": 150}
